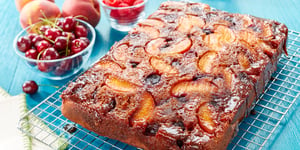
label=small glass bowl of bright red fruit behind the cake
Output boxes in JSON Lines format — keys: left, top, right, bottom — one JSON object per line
{"left": 100, "top": 0, "right": 147, "bottom": 31}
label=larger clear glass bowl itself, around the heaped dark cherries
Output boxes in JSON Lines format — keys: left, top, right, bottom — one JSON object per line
{"left": 13, "top": 19, "right": 96, "bottom": 80}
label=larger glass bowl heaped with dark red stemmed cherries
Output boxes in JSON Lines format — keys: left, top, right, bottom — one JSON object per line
{"left": 13, "top": 17, "right": 96, "bottom": 80}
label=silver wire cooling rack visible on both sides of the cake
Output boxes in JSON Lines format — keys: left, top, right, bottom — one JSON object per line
{"left": 19, "top": 31, "right": 300, "bottom": 150}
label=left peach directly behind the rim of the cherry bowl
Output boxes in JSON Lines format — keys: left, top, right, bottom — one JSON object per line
{"left": 20, "top": 0, "right": 61, "bottom": 28}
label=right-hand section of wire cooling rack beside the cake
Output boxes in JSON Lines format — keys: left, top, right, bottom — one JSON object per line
{"left": 228, "top": 31, "right": 300, "bottom": 149}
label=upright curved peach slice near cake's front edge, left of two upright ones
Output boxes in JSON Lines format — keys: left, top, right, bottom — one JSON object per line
{"left": 131, "top": 92, "right": 155, "bottom": 126}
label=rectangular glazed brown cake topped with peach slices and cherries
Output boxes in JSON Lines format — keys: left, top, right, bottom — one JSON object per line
{"left": 61, "top": 1, "right": 288, "bottom": 150}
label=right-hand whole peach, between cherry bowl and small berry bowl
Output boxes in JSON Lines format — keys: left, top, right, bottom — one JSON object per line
{"left": 62, "top": 0, "right": 101, "bottom": 27}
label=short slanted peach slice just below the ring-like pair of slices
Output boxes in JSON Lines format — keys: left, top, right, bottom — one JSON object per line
{"left": 150, "top": 57, "right": 178, "bottom": 74}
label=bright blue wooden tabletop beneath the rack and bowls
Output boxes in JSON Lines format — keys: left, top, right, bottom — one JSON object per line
{"left": 0, "top": 0, "right": 300, "bottom": 150}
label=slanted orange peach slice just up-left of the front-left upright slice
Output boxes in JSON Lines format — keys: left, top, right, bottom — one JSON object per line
{"left": 105, "top": 75, "right": 138, "bottom": 93}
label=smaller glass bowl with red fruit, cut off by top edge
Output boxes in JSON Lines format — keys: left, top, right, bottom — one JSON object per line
{"left": 100, "top": 0, "right": 148, "bottom": 31}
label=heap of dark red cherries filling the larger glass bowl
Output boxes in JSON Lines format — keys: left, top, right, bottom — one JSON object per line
{"left": 18, "top": 17, "right": 90, "bottom": 75}
